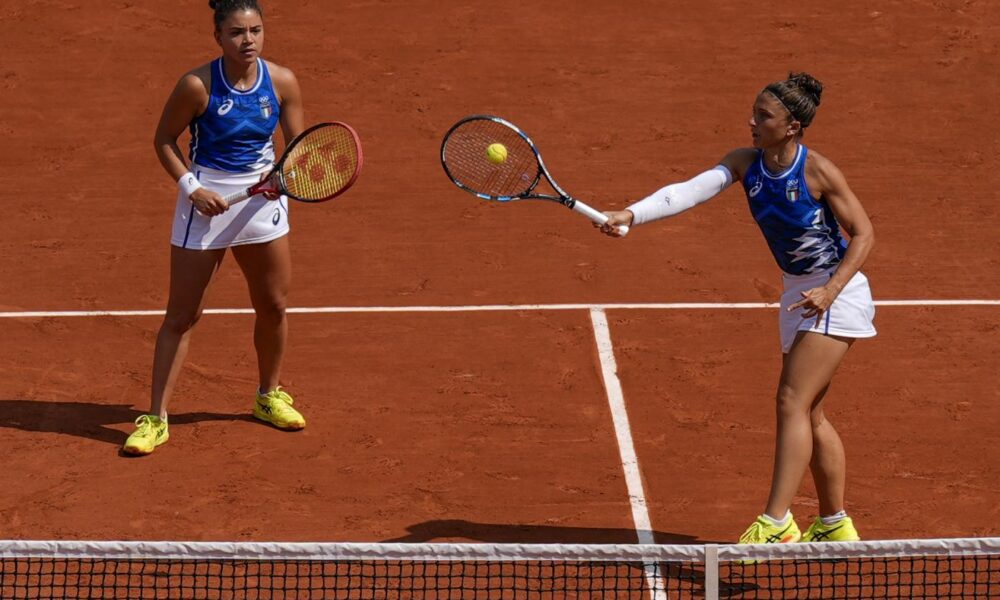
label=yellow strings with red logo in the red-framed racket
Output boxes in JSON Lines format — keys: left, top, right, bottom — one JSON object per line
{"left": 281, "top": 125, "right": 359, "bottom": 201}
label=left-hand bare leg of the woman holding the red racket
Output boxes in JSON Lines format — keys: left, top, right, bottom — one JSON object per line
{"left": 150, "top": 246, "right": 226, "bottom": 419}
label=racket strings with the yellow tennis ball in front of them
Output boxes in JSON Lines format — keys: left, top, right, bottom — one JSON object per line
{"left": 443, "top": 119, "right": 539, "bottom": 197}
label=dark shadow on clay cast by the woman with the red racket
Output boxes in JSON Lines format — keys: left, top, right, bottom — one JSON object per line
{"left": 0, "top": 400, "right": 254, "bottom": 446}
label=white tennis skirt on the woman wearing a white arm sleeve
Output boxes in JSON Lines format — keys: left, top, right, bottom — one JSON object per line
{"left": 779, "top": 270, "right": 875, "bottom": 353}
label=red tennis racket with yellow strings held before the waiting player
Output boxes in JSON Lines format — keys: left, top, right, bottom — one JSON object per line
{"left": 223, "top": 122, "right": 363, "bottom": 206}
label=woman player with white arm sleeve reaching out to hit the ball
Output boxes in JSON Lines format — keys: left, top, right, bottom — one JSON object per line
{"left": 601, "top": 73, "right": 875, "bottom": 544}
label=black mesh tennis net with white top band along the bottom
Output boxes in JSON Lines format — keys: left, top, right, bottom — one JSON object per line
{"left": 0, "top": 538, "right": 1000, "bottom": 600}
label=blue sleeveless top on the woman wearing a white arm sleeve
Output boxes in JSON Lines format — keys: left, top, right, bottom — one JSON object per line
{"left": 743, "top": 144, "right": 847, "bottom": 275}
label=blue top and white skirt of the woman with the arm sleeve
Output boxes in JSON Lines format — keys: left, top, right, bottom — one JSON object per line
{"left": 743, "top": 144, "right": 875, "bottom": 352}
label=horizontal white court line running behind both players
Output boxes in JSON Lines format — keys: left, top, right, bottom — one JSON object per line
{"left": 0, "top": 300, "right": 1000, "bottom": 319}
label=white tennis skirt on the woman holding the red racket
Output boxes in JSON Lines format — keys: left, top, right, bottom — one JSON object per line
{"left": 170, "top": 165, "right": 289, "bottom": 250}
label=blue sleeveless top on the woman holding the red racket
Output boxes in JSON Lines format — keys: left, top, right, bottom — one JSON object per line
{"left": 188, "top": 58, "right": 281, "bottom": 173}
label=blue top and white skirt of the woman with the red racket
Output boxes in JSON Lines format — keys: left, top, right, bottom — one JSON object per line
{"left": 170, "top": 58, "right": 289, "bottom": 250}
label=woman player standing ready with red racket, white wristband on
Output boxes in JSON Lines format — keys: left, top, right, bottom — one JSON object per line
{"left": 123, "top": 0, "right": 305, "bottom": 454}
